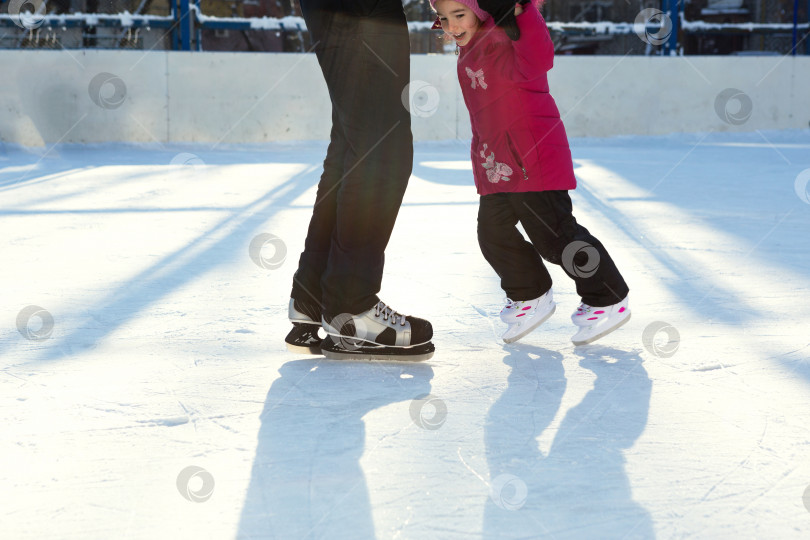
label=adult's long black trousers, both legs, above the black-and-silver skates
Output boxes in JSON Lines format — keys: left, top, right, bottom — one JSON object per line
{"left": 291, "top": 0, "right": 413, "bottom": 316}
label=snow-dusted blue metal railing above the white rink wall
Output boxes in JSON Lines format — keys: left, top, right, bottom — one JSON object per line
{"left": 0, "top": 8, "right": 810, "bottom": 56}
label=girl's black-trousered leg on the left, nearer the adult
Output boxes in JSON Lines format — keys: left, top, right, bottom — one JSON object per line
{"left": 478, "top": 193, "right": 551, "bottom": 301}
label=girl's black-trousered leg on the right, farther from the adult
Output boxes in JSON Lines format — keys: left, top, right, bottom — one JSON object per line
{"left": 509, "top": 191, "right": 629, "bottom": 307}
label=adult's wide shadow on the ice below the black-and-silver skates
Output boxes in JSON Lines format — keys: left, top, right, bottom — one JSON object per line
{"left": 237, "top": 359, "right": 433, "bottom": 540}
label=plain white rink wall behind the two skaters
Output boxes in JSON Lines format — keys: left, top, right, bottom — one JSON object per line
{"left": 0, "top": 50, "right": 810, "bottom": 146}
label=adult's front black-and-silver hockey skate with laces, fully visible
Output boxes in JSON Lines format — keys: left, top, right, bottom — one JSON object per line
{"left": 321, "top": 302, "right": 435, "bottom": 362}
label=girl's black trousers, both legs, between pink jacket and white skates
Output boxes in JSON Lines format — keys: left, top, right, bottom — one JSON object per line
{"left": 478, "top": 191, "right": 629, "bottom": 306}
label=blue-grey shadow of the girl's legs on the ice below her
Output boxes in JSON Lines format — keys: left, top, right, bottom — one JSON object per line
{"left": 483, "top": 346, "right": 655, "bottom": 539}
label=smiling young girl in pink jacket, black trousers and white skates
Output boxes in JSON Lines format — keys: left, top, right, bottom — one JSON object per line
{"left": 430, "top": 0, "right": 630, "bottom": 345}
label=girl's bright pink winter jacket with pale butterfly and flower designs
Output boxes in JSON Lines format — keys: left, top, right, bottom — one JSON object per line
{"left": 458, "top": 4, "right": 577, "bottom": 195}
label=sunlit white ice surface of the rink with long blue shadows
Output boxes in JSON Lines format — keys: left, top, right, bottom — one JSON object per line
{"left": 0, "top": 130, "right": 810, "bottom": 540}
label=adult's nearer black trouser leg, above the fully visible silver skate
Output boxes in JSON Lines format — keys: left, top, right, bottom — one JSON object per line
{"left": 321, "top": 5, "right": 413, "bottom": 315}
